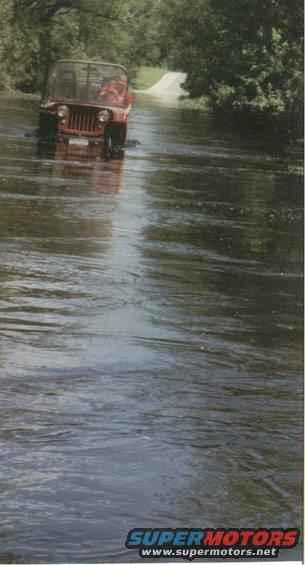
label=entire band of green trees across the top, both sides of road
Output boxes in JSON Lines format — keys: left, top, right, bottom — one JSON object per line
{"left": 0, "top": 0, "right": 303, "bottom": 129}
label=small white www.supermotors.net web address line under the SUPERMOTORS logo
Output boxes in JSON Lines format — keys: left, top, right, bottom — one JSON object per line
{"left": 139, "top": 547, "right": 279, "bottom": 561}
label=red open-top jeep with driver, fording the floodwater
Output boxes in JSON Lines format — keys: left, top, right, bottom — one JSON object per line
{"left": 38, "top": 59, "right": 131, "bottom": 149}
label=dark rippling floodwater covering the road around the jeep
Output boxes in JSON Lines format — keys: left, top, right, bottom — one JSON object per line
{"left": 0, "top": 93, "right": 302, "bottom": 563}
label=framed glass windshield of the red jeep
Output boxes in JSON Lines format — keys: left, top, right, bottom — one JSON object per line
{"left": 42, "top": 59, "right": 128, "bottom": 106}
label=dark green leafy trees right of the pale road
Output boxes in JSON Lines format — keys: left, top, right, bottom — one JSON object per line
{"left": 159, "top": 0, "right": 303, "bottom": 125}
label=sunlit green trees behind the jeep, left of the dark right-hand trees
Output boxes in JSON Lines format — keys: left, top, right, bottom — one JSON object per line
{"left": 0, "top": 0, "right": 160, "bottom": 92}
